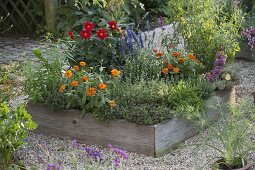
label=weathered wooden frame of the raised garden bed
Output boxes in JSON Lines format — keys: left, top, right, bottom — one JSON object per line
{"left": 27, "top": 87, "right": 235, "bottom": 157}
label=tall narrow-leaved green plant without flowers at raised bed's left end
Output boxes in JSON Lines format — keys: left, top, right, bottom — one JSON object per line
{"left": 23, "top": 41, "right": 70, "bottom": 108}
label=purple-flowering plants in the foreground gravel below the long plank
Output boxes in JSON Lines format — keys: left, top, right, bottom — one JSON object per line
{"left": 31, "top": 140, "right": 128, "bottom": 170}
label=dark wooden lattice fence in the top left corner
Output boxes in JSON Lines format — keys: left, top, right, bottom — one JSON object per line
{"left": 0, "top": 0, "right": 45, "bottom": 33}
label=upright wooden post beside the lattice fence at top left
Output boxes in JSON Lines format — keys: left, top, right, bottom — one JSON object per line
{"left": 44, "top": 0, "right": 58, "bottom": 32}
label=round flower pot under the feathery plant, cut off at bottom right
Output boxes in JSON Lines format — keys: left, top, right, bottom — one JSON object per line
{"left": 212, "top": 158, "right": 251, "bottom": 170}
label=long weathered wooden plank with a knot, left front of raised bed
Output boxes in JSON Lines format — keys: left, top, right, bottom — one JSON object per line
{"left": 27, "top": 103, "right": 154, "bottom": 156}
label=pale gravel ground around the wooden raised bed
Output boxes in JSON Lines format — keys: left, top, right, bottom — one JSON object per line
{"left": 0, "top": 35, "right": 255, "bottom": 170}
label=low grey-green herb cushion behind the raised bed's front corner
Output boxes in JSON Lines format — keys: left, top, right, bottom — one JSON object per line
{"left": 115, "top": 80, "right": 173, "bottom": 125}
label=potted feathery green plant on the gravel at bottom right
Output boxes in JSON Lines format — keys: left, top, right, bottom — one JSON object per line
{"left": 201, "top": 99, "right": 255, "bottom": 170}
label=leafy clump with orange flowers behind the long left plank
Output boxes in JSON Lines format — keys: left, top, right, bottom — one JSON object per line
{"left": 59, "top": 66, "right": 120, "bottom": 116}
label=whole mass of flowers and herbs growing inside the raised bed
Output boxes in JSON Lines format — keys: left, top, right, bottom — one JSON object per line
{"left": 24, "top": 21, "right": 238, "bottom": 125}
